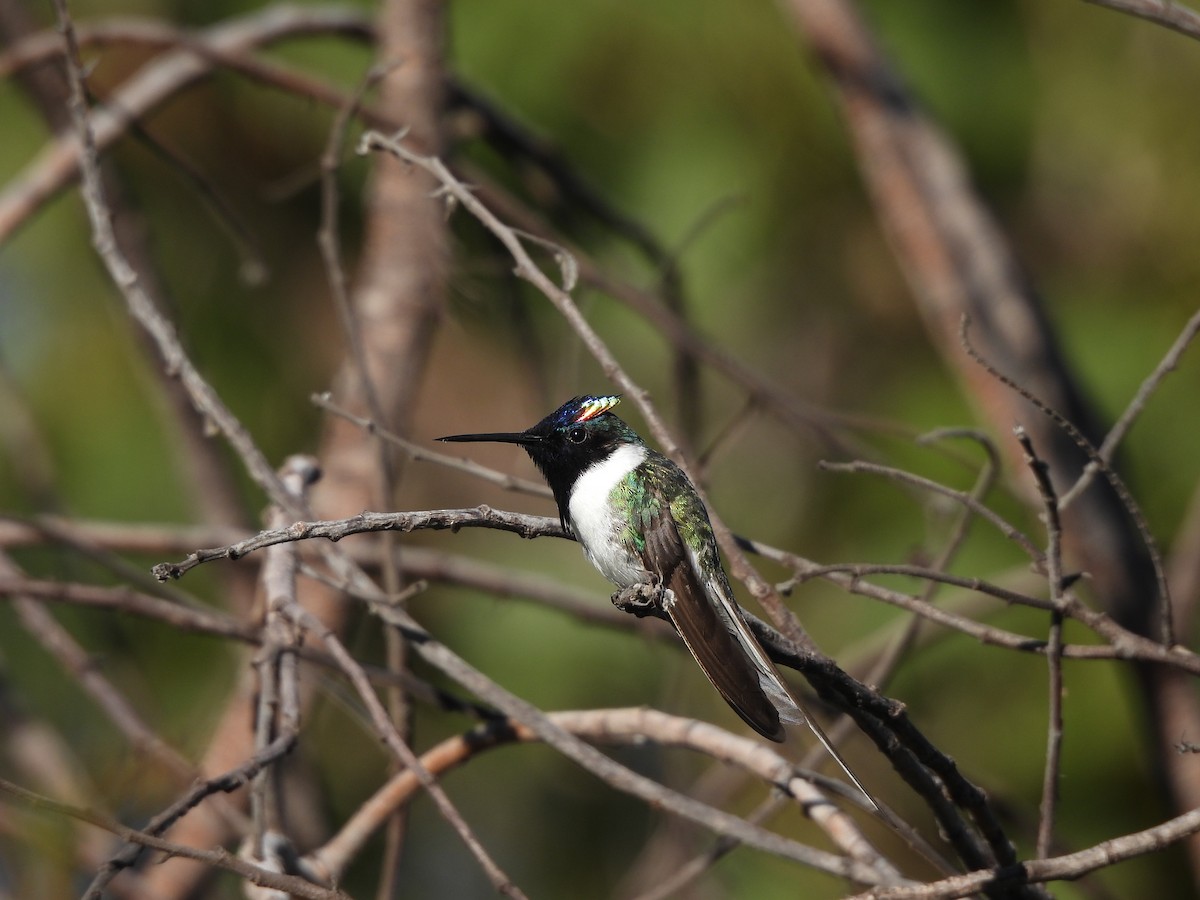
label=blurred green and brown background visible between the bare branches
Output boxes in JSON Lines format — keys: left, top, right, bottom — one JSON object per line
{"left": 0, "top": 0, "right": 1200, "bottom": 899}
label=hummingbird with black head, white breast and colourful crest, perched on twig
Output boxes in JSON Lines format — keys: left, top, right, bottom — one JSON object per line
{"left": 437, "top": 396, "right": 875, "bottom": 805}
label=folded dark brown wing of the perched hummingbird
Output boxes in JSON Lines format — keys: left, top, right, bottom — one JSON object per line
{"left": 642, "top": 504, "right": 784, "bottom": 742}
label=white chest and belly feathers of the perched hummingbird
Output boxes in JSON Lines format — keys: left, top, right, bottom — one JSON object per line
{"left": 568, "top": 444, "right": 647, "bottom": 588}
